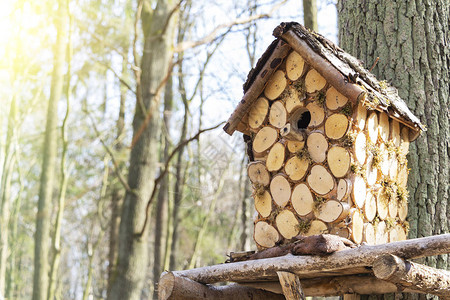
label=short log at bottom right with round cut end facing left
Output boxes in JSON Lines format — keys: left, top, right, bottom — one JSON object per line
{"left": 373, "top": 254, "right": 450, "bottom": 297}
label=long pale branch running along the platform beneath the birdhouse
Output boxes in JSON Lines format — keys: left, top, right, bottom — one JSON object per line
{"left": 174, "top": 234, "right": 450, "bottom": 283}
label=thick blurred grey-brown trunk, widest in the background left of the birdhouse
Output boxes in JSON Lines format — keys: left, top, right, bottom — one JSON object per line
{"left": 108, "top": 0, "right": 172, "bottom": 299}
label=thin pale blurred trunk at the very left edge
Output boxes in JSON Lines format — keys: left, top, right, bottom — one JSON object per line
{"left": 0, "top": 98, "right": 17, "bottom": 295}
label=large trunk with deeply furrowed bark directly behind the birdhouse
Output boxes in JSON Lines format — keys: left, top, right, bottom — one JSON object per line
{"left": 338, "top": 0, "right": 450, "bottom": 299}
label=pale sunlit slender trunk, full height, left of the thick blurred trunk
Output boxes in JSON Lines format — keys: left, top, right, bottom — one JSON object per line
{"left": 33, "top": 0, "right": 67, "bottom": 300}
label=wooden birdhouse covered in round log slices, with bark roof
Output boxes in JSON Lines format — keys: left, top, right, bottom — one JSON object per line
{"left": 224, "top": 23, "right": 425, "bottom": 249}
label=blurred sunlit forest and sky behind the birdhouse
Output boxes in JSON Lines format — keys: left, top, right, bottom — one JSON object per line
{"left": 0, "top": 0, "right": 448, "bottom": 300}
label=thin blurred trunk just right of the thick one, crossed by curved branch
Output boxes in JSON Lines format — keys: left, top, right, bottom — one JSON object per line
{"left": 153, "top": 77, "right": 173, "bottom": 299}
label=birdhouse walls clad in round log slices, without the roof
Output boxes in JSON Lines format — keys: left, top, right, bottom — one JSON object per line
{"left": 245, "top": 51, "right": 409, "bottom": 249}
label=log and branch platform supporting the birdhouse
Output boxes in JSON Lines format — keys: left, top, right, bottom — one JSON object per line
{"left": 159, "top": 234, "right": 450, "bottom": 300}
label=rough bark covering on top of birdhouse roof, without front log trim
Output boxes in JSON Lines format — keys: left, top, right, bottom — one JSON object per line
{"left": 224, "top": 22, "right": 426, "bottom": 133}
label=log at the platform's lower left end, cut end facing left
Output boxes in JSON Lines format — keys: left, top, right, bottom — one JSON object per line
{"left": 158, "top": 272, "right": 285, "bottom": 300}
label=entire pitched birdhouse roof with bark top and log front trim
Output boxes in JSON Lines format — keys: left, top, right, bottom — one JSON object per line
{"left": 224, "top": 22, "right": 425, "bottom": 140}
